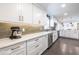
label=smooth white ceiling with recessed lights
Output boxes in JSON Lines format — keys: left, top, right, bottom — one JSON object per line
{"left": 39, "top": 3, "right": 79, "bottom": 17}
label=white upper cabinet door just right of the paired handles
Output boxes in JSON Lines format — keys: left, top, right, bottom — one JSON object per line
{"left": 22, "top": 3, "right": 32, "bottom": 24}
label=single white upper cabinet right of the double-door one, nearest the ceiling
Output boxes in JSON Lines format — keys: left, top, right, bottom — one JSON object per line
{"left": 32, "top": 4, "right": 46, "bottom": 25}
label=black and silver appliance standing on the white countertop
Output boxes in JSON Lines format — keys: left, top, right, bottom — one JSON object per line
{"left": 10, "top": 27, "right": 22, "bottom": 39}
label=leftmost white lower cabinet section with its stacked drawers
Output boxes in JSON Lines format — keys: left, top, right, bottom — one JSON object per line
{"left": 0, "top": 42, "right": 26, "bottom": 55}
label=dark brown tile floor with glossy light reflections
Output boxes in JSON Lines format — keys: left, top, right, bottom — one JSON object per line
{"left": 42, "top": 38, "right": 79, "bottom": 55}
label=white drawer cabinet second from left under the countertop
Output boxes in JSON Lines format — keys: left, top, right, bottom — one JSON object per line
{"left": 27, "top": 38, "right": 42, "bottom": 55}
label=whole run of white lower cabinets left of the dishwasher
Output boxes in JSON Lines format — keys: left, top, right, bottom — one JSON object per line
{"left": 0, "top": 35, "right": 48, "bottom": 55}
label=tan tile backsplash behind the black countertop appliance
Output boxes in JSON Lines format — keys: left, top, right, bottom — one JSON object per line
{"left": 0, "top": 22, "right": 43, "bottom": 38}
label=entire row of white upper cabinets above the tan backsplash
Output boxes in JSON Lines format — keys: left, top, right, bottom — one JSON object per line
{"left": 0, "top": 3, "right": 46, "bottom": 25}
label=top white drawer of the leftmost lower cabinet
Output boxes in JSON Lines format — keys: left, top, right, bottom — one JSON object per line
{"left": 0, "top": 42, "right": 26, "bottom": 55}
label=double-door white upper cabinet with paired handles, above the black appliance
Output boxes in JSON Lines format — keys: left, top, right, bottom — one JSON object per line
{"left": 0, "top": 3, "right": 32, "bottom": 24}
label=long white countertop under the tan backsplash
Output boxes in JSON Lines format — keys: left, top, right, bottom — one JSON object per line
{"left": 0, "top": 31, "right": 53, "bottom": 48}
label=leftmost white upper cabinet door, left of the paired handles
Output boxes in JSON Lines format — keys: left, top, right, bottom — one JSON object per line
{"left": 0, "top": 3, "right": 18, "bottom": 22}
